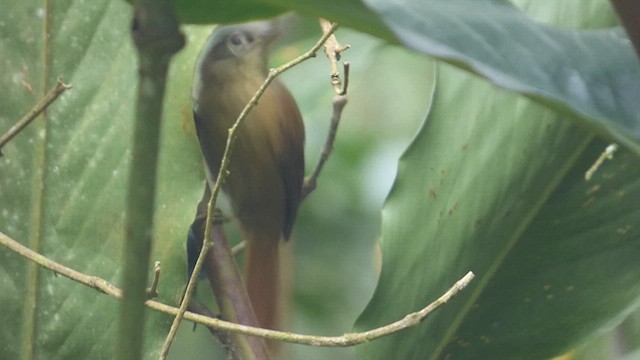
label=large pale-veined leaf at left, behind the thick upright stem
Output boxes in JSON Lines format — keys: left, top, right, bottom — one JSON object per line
{"left": 0, "top": 0, "right": 202, "bottom": 359}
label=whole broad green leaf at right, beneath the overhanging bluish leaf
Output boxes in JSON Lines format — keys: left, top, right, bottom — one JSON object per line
{"left": 357, "top": 0, "right": 640, "bottom": 359}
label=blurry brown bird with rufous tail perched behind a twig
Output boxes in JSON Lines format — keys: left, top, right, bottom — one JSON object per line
{"left": 189, "top": 21, "right": 305, "bottom": 329}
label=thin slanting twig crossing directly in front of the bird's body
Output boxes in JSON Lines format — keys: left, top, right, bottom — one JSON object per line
{"left": 161, "top": 24, "right": 338, "bottom": 359}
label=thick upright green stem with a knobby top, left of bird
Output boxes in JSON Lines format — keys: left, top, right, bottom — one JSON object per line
{"left": 117, "top": 0, "right": 184, "bottom": 360}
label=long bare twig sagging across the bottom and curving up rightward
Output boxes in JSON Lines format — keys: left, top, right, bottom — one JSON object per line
{"left": 0, "top": 232, "right": 475, "bottom": 347}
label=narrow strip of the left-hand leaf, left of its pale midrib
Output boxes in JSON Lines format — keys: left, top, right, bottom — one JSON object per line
{"left": 0, "top": 1, "right": 44, "bottom": 359}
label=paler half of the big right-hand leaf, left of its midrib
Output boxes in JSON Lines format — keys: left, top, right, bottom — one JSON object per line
{"left": 358, "top": 62, "right": 590, "bottom": 359}
